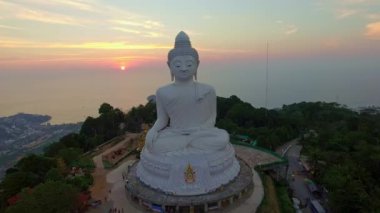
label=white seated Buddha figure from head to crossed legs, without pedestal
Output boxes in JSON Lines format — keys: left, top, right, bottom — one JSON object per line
{"left": 146, "top": 31, "right": 229, "bottom": 153}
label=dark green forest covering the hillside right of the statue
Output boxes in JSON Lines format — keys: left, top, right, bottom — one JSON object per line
{"left": 216, "top": 96, "right": 380, "bottom": 212}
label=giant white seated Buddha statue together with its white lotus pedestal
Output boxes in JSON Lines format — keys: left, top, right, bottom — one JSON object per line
{"left": 137, "top": 32, "right": 240, "bottom": 195}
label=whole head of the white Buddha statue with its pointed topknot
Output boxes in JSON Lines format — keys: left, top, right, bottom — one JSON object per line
{"left": 168, "top": 31, "right": 199, "bottom": 81}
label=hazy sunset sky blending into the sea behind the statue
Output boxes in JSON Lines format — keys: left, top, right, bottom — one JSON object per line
{"left": 0, "top": 0, "right": 380, "bottom": 122}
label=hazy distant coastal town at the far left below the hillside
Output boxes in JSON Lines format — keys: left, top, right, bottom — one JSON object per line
{"left": 0, "top": 113, "right": 82, "bottom": 180}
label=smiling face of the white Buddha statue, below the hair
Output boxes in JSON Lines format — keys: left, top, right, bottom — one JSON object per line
{"left": 169, "top": 55, "right": 198, "bottom": 81}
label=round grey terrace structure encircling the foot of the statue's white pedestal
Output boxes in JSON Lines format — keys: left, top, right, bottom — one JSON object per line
{"left": 125, "top": 158, "right": 253, "bottom": 212}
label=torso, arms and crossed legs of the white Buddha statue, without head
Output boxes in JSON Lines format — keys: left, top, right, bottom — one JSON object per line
{"left": 147, "top": 82, "right": 229, "bottom": 153}
